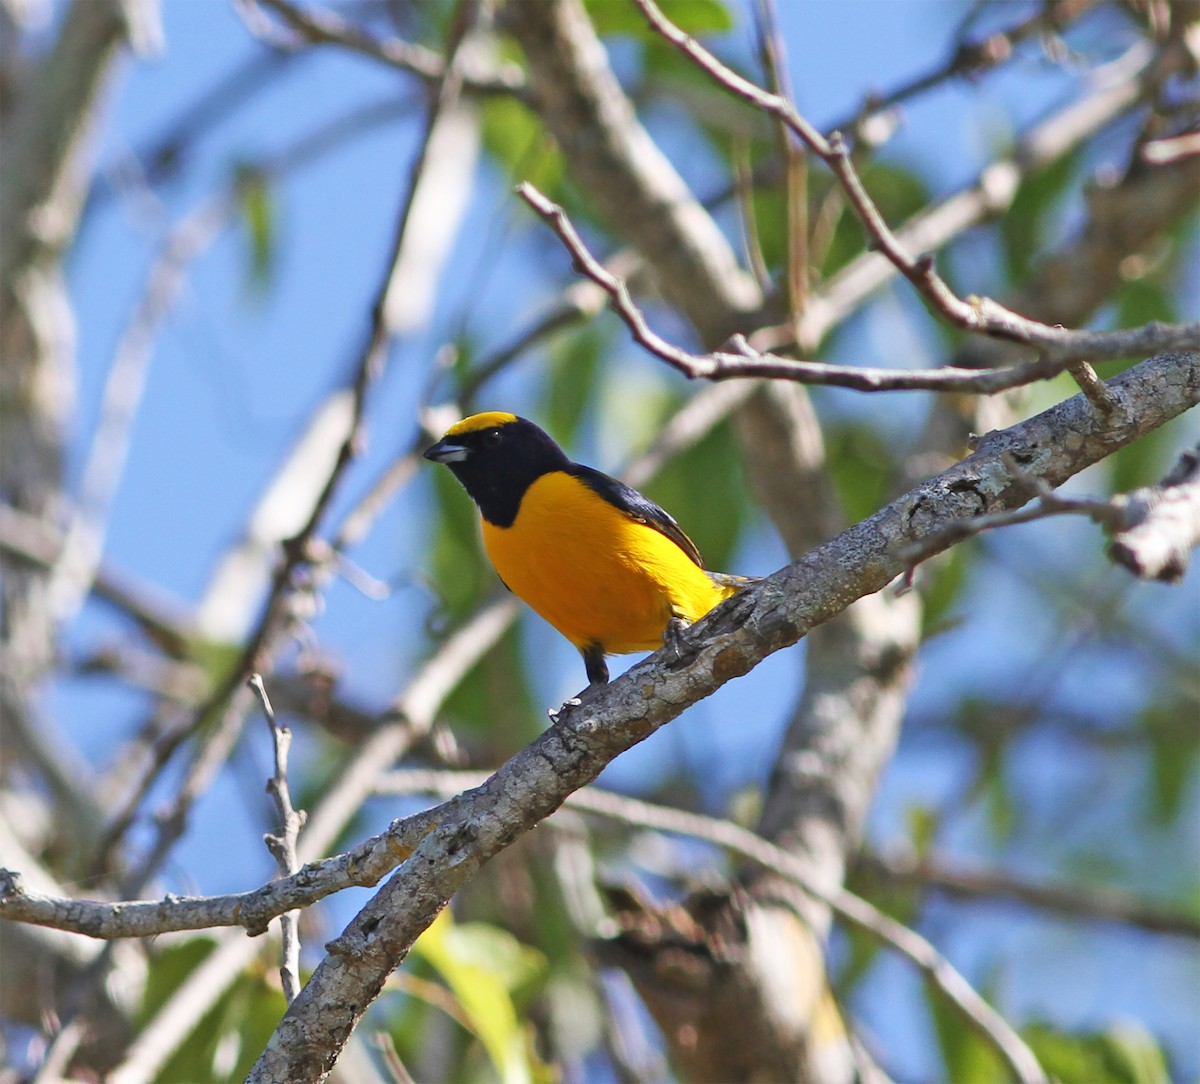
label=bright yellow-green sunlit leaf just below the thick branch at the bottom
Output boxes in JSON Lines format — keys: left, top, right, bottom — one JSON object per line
{"left": 413, "top": 911, "right": 546, "bottom": 1084}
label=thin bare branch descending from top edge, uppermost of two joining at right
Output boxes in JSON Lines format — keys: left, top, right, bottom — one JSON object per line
{"left": 635, "top": 0, "right": 1200, "bottom": 367}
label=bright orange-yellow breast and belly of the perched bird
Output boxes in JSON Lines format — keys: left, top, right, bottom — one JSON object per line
{"left": 484, "top": 472, "right": 732, "bottom": 654}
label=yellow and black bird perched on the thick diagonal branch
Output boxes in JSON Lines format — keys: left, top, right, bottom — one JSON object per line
{"left": 425, "top": 411, "right": 752, "bottom": 688}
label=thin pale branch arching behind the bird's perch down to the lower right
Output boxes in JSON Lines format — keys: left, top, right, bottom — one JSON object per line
{"left": 378, "top": 769, "right": 1045, "bottom": 1082}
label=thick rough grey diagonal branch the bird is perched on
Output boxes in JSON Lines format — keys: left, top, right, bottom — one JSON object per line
{"left": 250, "top": 357, "right": 1200, "bottom": 1084}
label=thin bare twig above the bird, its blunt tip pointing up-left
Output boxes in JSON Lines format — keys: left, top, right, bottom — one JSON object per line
{"left": 517, "top": 181, "right": 1200, "bottom": 395}
